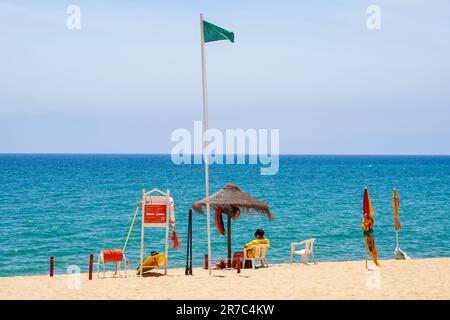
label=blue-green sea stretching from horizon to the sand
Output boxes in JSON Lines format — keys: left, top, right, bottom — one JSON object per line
{"left": 0, "top": 154, "right": 450, "bottom": 276}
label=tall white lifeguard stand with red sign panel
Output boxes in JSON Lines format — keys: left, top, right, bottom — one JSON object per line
{"left": 140, "top": 189, "right": 173, "bottom": 276}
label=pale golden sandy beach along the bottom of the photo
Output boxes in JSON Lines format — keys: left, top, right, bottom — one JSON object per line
{"left": 0, "top": 258, "right": 450, "bottom": 300}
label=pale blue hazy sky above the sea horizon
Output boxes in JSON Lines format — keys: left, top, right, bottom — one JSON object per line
{"left": 0, "top": 0, "right": 450, "bottom": 154}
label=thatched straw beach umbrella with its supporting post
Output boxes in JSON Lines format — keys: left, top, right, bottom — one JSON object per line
{"left": 192, "top": 184, "right": 273, "bottom": 267}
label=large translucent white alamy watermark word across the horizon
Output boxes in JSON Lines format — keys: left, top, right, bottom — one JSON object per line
{"left": 171, "top": 121, "right": 280, "bottom": 175}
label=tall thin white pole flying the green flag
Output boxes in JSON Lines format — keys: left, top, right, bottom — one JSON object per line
{"left": 200, "top": 13, "right": 211, "bottom": 275}
